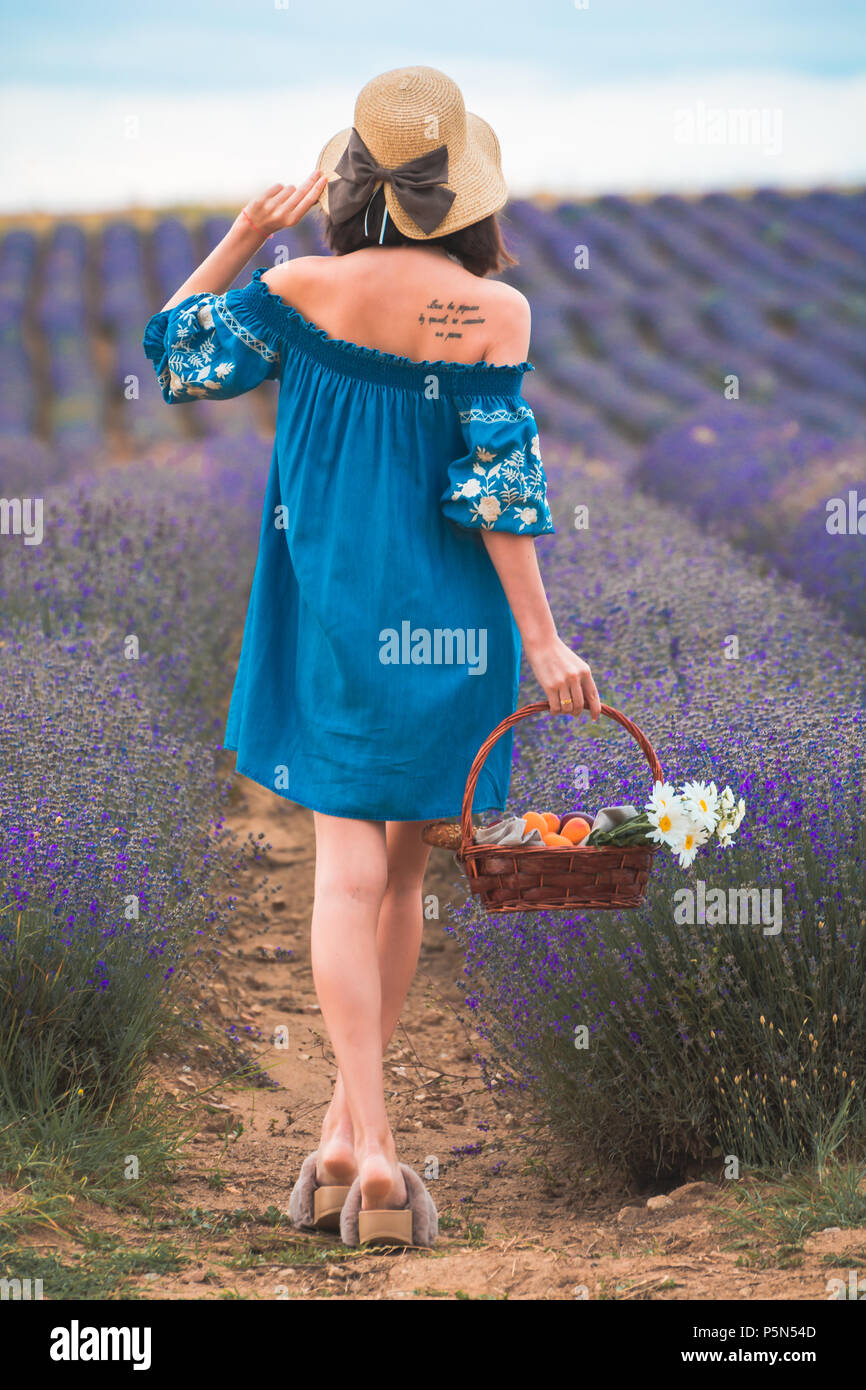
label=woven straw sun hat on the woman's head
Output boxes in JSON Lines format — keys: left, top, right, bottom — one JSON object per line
{"left": 316, "top": 67, "right": 507, "bottom": 240}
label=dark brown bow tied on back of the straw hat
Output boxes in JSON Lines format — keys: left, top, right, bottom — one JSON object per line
{"left": 328, "top": 126, "right": 457, "bottom": 236}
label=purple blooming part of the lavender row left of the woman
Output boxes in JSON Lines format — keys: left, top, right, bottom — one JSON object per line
{"left": 0, "top": 438, "right": 268, "bottom": 990}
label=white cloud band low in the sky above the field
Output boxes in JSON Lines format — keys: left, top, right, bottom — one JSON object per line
{"left": 0, "top": 63, "right": 866, "bottom": 211}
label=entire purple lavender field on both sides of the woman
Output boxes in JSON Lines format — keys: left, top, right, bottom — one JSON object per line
{"left": 0, "top": 190, "right": 866, "bottom": 1212}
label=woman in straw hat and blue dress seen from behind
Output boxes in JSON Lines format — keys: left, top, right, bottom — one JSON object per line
{"left": 145, "top": 67, "right": 601, "bottom": 1245}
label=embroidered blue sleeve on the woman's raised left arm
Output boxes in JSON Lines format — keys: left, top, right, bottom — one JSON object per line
{"left": 145, "top": 281, "right": 279, "bottom": 404}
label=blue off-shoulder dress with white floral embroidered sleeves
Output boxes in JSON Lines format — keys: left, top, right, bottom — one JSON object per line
{"left": 145, "top": 267, "right": 553, "bottom": 820}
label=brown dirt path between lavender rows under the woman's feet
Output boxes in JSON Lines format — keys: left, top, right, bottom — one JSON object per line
{"left": 111, "top": 778, "right": 866, "bottom": 1300}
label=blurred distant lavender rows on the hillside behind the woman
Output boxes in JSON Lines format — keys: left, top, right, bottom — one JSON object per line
{"left": 0, "top": 189, "right": 866, "bottom": 617}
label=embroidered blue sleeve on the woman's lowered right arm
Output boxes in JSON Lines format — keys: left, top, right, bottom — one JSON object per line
{"left": 439, "top": 396, "right": 555, "bottom": 535}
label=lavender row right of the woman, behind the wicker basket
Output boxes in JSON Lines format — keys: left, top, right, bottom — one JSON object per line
{"left": 453, "top": 442, "right": 866, "bottom": 1182}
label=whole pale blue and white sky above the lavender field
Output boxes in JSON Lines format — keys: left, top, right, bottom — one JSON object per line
{"left": 0, "top": 0, "right": 866, "bottom": 213}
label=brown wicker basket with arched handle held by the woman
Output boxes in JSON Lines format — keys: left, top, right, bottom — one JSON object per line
{"left": 456, "top": 701, "right": 663, "bottom": 912}
